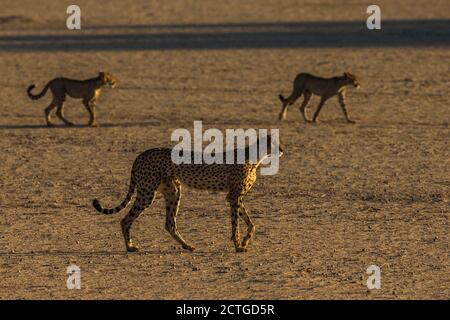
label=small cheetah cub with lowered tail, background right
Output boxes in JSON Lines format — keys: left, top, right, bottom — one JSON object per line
{"left": 278, "top": 72, "right": 360, "bottom": 123}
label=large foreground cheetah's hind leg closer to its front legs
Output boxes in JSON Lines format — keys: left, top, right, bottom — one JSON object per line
{"left": 158, "top": 179, "right": 195, "bottom": 251}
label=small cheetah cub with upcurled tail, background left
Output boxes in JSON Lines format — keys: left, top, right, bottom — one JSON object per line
{"left": 27, "top": 72, "right": 117, "bottom": 127}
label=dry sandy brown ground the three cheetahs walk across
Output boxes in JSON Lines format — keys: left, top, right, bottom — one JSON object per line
{"left": 0, "top": 0, "right": 450, "bottom": 299}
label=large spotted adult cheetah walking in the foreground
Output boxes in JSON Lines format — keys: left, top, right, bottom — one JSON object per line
{"left": 93, "top": 135, "right": 283, "bottom": 252}
